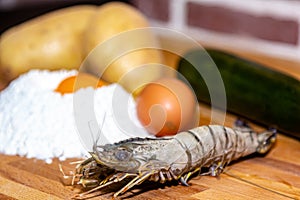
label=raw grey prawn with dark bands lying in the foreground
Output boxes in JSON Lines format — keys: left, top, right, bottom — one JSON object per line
{"left": 63, "top": 121, "right": 276, "bottom": 198}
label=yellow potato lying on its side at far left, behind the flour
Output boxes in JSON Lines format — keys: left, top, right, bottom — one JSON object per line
{"left": 0, "top": 5, "right": 97, "bottom": 80}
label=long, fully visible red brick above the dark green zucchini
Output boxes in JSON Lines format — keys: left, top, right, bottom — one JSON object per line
{"left": 187, "top": 2, "right": 299, "bottom": 45}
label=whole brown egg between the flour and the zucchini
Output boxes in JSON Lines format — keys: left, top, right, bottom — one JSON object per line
{"left": 137, "top": 78, "right": 199, "bottom": 137}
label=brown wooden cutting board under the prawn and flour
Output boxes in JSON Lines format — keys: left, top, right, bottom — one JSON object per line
{"left": 0, "top": 50, "right": 300, "bottom": 200}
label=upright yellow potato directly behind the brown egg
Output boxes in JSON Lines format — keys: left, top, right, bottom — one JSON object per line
{"left": 83, "top": 2, "right": 168, "bottom": 92}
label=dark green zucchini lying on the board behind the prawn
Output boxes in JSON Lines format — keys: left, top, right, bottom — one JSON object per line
{"left": 178, "top": 49, "right": 300, "bottom": 138}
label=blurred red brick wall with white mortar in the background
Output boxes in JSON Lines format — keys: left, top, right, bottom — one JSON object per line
{"left": 131, "top": 0, "right": 300, "bottom": 62}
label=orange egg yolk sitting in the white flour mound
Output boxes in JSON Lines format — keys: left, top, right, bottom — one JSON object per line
{"left": 55, "top": 73, "right": 108, "bottom": 94}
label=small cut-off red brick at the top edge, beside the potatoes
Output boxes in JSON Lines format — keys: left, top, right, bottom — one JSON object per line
{"left": 131, "top": 0, "right": 170, "bottom": 22}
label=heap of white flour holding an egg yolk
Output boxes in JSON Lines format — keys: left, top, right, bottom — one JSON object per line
{"left": 0, "top": 70, "right": 148, "bottom": 163}
